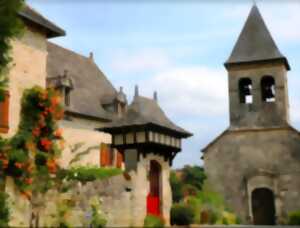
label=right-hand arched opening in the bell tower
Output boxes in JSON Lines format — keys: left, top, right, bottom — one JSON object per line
{"left": 261, "top": 76, "right": 276, "bottom": 102}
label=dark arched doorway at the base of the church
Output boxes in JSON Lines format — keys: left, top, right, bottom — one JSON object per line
{"left": 251, "top": 188, "right": 276, "bottom": 225}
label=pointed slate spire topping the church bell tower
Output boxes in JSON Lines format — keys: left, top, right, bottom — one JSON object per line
{"left": 225, "top": 4, "right": 290, "bottom": 70}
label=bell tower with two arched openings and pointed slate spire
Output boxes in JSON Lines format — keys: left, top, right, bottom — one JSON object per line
{"left": 225, "top": 5, "right": 290, "bottom": 129}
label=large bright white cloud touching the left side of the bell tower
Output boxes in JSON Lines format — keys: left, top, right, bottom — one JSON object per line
{"left": 141, "top": 66, "right": 228, "bottom": 118}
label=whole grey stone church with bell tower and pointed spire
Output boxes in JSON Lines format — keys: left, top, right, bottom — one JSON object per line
{"left": 203, "top": 6, "right": 300, "bottom": 225}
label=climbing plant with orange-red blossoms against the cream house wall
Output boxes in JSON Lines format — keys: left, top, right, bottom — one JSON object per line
{"left": 0, "top": 87, "right": 64, "bottom": 199}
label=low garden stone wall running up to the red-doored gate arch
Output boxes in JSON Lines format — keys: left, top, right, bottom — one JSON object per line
{"left": 6, "top": 151, "right": 172, "bottom": 227}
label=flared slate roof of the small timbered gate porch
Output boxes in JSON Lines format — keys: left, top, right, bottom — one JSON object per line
{"left": 101, "top": 96, "right": 192, "bottom": 137}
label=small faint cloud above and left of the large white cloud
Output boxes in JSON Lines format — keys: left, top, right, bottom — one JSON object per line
{"left": 111, "top": 48, "right": 170, "bottom": 73}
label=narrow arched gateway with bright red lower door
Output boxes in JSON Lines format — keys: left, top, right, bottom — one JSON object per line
{"left": 147, "top": 160, "right": 162, "bottom": 216}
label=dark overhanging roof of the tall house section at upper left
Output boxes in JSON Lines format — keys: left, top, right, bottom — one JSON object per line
{"left": 19, "top": 5, "right": 66, "bottom": 38}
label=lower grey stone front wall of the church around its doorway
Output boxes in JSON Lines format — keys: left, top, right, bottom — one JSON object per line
{"left": 204, "top": 129, "right": 300, "bottom": 223}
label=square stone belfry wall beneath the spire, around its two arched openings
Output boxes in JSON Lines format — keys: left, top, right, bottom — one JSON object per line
{"left": 228, "top": 63, "right": 289, "bottom": 129}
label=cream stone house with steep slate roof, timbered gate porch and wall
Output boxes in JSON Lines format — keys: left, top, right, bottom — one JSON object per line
{"left": 0, "top": 3, "right": 190, "bottom": 227}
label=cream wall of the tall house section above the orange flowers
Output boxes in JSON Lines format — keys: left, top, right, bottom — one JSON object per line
{"left": 3, "top": 28, "right": 47, "bottom": 137}
